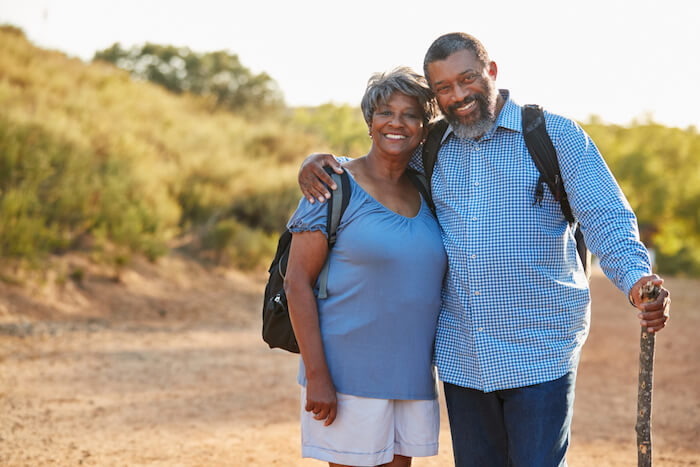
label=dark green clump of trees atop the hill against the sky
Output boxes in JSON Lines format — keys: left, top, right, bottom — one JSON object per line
{"left": 94, "top": 43, "right": 283, "bottom": 114}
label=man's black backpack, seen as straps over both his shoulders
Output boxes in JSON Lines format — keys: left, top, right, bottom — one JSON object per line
{"left": 423, "top": 105, "right": 591, "bottom": 279}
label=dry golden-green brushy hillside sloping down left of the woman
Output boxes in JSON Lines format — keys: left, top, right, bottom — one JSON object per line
{"left": 0, "top": 26, "right": 326, "bottom": 272}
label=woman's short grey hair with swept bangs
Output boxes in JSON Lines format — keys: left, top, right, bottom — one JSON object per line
{"left": 360, "top": 67, "right": 436, "bottom": 127}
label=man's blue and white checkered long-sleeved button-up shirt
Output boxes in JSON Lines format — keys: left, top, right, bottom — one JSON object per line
{"left": 411, "top": 90, "right": 651, "bottom": 392}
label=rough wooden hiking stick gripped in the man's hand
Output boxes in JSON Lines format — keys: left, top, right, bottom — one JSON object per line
{"left": 635, "top": 281, "right": 661, "bottom": 467}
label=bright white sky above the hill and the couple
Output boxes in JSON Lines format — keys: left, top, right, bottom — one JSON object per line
{"left": 0, "top": 0, "right": 700, "bottom": 128}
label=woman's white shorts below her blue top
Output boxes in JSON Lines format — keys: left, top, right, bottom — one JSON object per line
{"left": 301, "top": 387, "right": 440, "bottom": 466}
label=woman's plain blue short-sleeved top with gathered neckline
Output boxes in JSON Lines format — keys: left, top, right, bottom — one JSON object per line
{"left": 287, "top": 172, "right": 447, "bottom": 400}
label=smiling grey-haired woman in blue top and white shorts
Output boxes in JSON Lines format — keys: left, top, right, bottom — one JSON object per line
{"left": 285, "top": 68, "right": 446, "bottom": 466}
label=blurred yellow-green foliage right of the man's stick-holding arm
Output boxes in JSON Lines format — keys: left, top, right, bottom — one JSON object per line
{"left": 586, "top": 122, "right": 700, "bottom": 276}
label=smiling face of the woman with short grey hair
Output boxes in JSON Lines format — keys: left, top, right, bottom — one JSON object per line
{"left": 370, "top": 92, "right": 427, "bottom": 156}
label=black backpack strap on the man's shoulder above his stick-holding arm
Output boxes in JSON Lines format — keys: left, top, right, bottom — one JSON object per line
{"left": 522, "top": 104, "right": 574, "bottom": 224}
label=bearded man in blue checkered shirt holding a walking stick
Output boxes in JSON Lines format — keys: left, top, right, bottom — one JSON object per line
{"left": 300, "top": 33, "right": 670, "bottom": 467}
